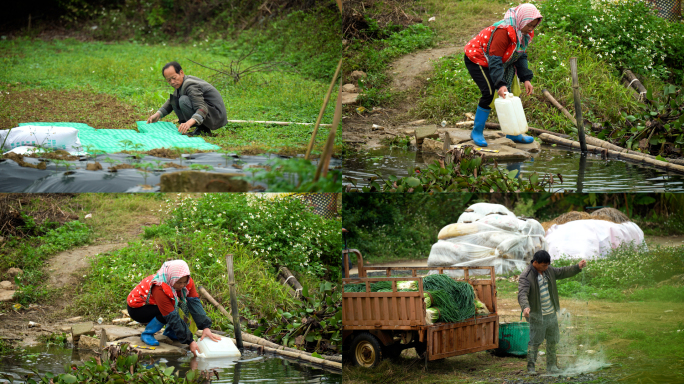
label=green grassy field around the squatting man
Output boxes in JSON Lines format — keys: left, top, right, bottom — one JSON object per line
{"left": 0, "top": 19, "right": 339, "bottom": 154}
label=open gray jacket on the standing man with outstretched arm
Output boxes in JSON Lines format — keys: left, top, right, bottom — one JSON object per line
{"left": 518, "top": 263, "right": 582, "bottom": 322}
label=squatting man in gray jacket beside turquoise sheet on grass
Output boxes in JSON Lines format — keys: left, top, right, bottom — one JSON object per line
{"left": 147, "top": 61, "right": 228, "bottom": 136}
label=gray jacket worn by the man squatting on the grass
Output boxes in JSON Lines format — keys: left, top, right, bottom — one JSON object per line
{"left": 159, "top": 75, "right": 228, "bottom": 129}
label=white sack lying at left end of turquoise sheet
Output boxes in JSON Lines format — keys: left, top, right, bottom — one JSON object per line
{"left": 0, "top": 125, "right": 82, "bottom": 153}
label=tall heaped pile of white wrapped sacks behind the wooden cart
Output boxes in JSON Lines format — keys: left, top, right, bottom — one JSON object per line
{"left": 428, "top": 203, "right": 547, "bottom": 275}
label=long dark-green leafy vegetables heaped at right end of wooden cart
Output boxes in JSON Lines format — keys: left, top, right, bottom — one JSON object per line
{"left": 423, "top": 274, "right": 475, "bottom": 323}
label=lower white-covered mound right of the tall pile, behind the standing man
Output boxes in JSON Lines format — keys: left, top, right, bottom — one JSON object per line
{"left": 546, "top": 220, "right": 644, "bottom": 259}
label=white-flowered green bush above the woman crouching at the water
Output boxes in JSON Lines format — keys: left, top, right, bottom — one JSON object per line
{"left": 154, "top": 193, "right": 342, "bottom": 281}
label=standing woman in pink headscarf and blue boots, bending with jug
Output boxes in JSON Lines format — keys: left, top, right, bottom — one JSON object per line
{"left": 464, "top": 4, "right": 542, "bottom": 147}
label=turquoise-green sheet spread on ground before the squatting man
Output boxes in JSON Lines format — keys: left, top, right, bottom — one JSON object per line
{"left": 19, "top": 121, "right": 221, "bottom": 153}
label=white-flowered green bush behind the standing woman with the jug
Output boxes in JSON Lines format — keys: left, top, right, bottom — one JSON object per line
{"left": 537, "top": 0, "right": 684, "bottom": 82}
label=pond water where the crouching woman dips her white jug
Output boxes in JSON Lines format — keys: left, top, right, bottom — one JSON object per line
{"left": 0, "top": 345, "right": 342, "bottom": 384}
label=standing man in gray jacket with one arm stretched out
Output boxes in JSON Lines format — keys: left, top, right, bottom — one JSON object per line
{"left": 518, "top": 250, "right": 587, "bottom": 375}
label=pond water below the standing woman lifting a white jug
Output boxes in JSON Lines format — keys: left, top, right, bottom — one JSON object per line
{"left": 343, "top": 146, "right": 684, "bottom": 193}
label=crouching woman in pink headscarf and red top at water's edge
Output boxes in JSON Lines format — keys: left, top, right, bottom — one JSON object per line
{"left": 126, "top": 260, "right": 221, "bottom": 355}
